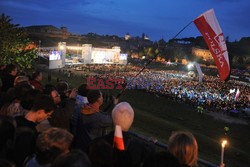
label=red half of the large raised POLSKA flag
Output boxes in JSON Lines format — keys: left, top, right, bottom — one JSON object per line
{"left": 194, "top": 16, "right": 230, "bottom": 80}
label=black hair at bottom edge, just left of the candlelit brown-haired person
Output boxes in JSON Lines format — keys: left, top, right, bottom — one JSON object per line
{"left": 143, "top": 151, "right": 181, "bottom": 167}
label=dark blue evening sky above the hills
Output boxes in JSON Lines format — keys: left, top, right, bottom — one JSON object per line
{"left": 0, "top": 0, "right": 250, "bottom": 41}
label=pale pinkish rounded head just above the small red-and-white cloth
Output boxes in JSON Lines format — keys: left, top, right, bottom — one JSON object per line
{"left": 112, "top": 102, "right": 134, "bottom": 131}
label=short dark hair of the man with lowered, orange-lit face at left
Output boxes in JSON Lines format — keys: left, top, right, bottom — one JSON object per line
{"left": 31, "top": 95, "right": 56, "bottom": 113}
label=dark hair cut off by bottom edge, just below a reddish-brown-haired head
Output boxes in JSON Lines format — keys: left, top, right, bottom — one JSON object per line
{"left": 51, "top": 150, "right": 91, "bottom": 167}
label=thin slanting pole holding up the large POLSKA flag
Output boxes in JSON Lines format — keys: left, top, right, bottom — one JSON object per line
{"left": 103, "top": 21, "right": 193, "bottom": 112}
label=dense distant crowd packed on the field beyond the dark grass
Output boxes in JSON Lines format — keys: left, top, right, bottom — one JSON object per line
{"left": 95, "top": 69, "right": 250, "bottom": 113}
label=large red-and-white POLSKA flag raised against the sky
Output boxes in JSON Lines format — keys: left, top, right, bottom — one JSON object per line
{"left": 194, "top": 9, "right": 230, "bottom": 80}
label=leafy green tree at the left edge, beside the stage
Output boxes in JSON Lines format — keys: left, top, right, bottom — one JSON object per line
{"left": 0, "top": 14, "right": 37, "bottom": 69}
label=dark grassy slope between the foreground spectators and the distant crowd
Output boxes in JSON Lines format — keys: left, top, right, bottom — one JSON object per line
{"left": 42, "top": 68, "right": 250, "bottom": 167}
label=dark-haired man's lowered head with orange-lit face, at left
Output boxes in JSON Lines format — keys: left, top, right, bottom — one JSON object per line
{"left": 31, "top": 95, "right": 55, "bottom": 122}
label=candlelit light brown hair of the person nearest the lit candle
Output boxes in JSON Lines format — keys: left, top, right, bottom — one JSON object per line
{"left": 168, "top": 131, "right": 198, "bottom": 167}
